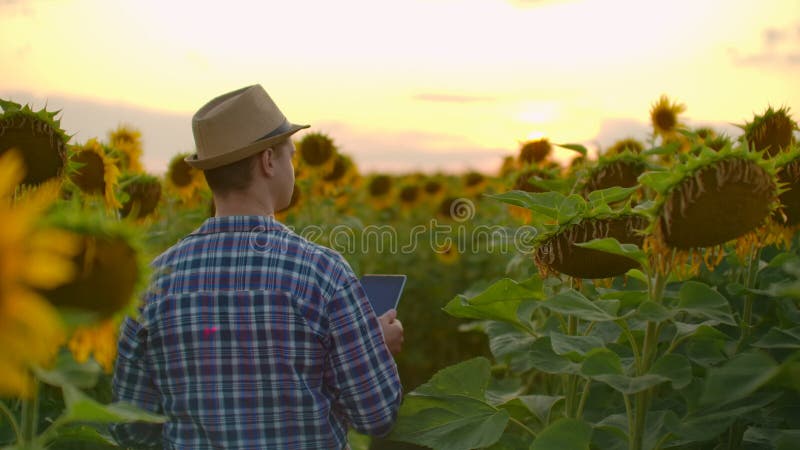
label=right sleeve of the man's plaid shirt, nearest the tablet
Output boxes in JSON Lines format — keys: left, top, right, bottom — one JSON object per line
{"left": 325, "top": 278, "right": 402, "bottom": 436}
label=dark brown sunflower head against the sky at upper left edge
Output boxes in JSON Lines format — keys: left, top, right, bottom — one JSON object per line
{"left": 0, "top": 99, "right": 69, "bottom": 185}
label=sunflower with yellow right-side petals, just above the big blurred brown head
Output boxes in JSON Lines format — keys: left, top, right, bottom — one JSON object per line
{"left": 69, "top": 139, "right": 122, "bottom": 209}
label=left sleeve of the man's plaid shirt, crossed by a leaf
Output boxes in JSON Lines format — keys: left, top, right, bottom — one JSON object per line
{"left": 109, "top": 317, "right": 163, "bottom": 449}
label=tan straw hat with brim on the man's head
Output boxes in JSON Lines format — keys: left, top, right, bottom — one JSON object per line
{"left": 185, "top": 84, "right": 309, "bottom": 170}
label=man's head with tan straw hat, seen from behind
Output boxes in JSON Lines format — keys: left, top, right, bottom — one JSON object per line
{"left": 186, "top": 85, "right": 308, "bottom": 214}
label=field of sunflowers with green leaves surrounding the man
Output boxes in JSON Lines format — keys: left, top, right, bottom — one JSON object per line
{"left": 0, "top": 96, "right": 800, "bottom": 450}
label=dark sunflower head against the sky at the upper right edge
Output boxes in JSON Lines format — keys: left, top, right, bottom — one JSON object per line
{"left": 743, "top": 107, "right": 798, "bottom": 156}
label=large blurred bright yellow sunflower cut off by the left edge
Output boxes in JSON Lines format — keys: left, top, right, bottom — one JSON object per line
{"left": 0, "top": 150, "right": 77, "bottom": 396}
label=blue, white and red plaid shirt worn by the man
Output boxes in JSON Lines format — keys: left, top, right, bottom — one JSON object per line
{"left": 111, "top": 216, "right": 402, "bottom": 450}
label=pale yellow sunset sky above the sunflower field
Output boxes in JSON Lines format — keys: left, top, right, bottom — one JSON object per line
{"left": 0, "top": 0, "right": 800, "bottom": 173}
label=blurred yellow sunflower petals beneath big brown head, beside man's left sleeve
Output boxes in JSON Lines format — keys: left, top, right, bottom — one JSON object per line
{"left": 67, "top": 317, "right": 120, "bottom": 373}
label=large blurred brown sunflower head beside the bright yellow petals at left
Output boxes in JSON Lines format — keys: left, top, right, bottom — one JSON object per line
{"left": 42, "top": 211, "right": 147, "bottom": 320}
